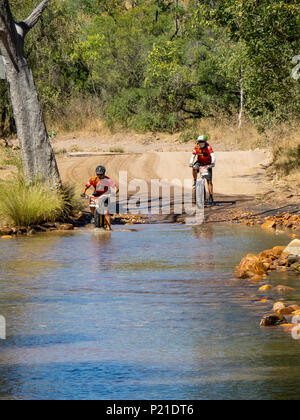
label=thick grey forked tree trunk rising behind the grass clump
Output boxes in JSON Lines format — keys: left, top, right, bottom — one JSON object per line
{"left": 0, "top": 0, "right": 61, "bottom": 187}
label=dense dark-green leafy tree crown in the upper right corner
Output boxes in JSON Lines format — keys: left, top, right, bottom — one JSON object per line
{"left": 199, "top": 0, "right": 300, "bottom": 129}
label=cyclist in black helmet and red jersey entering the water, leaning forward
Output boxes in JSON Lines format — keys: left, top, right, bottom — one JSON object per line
{"left": 81, "top": 166, "right": 119, "bottom": 230}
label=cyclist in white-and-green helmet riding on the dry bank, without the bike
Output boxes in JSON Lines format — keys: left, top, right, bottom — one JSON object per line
{"left": 190, "top": 136, "right": 216, "bottom": 205}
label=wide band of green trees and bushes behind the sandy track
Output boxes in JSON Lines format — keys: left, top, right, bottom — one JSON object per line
{"left": 0, "top": 0, "right": 300, "bottom": 135}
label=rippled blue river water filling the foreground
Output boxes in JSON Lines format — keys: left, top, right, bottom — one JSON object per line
{"left": 0, "top": 225, "right": 300, "bottom": 400}
